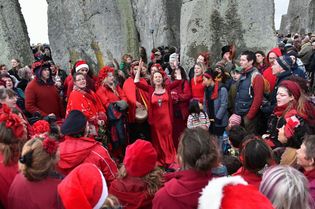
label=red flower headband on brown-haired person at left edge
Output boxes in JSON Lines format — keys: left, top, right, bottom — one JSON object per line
{"left": 0, "top": 104, "right": 24, "bottom": 138}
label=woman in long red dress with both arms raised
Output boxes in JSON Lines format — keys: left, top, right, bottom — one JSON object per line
{"left": 134, "top": 61, "right": 181, "bottom": 167}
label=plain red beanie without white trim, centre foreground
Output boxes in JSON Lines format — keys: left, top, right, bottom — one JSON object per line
{"left": 124, "top": 139, "right": 157, "bottom": 177}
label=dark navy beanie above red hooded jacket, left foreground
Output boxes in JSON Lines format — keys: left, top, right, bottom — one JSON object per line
{"left": 60, "top": 110, "right": 87, "bottom": 135}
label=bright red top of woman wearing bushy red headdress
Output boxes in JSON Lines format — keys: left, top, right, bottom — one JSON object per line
{"left": 96, "top": 86, "right": 127, "bottom": 110}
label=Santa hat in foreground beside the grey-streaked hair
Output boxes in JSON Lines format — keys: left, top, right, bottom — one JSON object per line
{"left": 198, "top": 176, "right": 274, "bottom": 209}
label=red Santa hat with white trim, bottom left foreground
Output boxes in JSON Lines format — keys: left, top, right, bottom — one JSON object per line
{"left": 58, "top": 163, "right": 108, "bottom": 209}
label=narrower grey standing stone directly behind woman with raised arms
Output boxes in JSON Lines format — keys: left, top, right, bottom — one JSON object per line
{"left": 131, "top": 0, "right": 182, "bottom": 55}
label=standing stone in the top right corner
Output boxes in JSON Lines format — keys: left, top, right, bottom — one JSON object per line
{"left": 280, "top": 0, "right": 315, "bottom": 34}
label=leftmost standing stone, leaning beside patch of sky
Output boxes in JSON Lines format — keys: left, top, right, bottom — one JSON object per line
{"left": 0, "top": 0, "right": 33, "bottom": 68}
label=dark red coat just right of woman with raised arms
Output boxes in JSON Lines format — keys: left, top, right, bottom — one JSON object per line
{"left": 171, "top": 80, "right": 191, "bottom": 121}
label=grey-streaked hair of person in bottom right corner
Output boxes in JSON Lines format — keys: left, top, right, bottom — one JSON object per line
{"left": 259, "top": 166, "right": 314, "bottom": 209}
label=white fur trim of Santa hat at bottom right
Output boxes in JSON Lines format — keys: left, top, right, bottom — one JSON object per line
{"left": 198, "top": 176, "right": 248, "bottom": 209}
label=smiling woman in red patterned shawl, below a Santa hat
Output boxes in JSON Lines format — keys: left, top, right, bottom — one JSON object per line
{"left": 66, "top": 73, "right": 107, "bottom": 136}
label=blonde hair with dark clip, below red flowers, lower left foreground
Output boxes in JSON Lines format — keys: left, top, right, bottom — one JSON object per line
{"left": 19, "top": 137, "right": 59, "bottom": 181}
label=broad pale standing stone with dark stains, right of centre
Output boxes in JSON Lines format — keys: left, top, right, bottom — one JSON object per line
{"left": 180, "top": 0, "right": 276, "bottom": 70}
